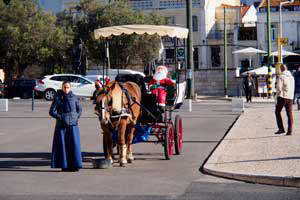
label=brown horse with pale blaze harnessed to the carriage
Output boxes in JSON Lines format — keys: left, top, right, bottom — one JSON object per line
{"left": 95, "top": 81, "right": 141, "bottom": 166}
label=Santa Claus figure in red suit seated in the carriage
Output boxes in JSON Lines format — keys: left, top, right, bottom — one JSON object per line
{"left": 149, "top": 65, "right": 175, "bottom": 107}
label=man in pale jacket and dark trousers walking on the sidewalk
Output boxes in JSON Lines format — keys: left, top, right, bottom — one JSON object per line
{"left": 275, "top": 64, "right": 295, "bottom": 135}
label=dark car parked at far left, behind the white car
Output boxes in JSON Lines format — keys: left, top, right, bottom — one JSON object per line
{"left": 7, "top": 79, "right": 36, "bottom": 99}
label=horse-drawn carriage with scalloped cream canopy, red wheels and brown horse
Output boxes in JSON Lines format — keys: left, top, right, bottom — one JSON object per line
{"left": 94, "top": 25, "right": 188, "bottom": 166}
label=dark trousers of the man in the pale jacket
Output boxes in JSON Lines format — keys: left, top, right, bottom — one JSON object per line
{"left": 275, "top": 97, "right": 294, "bottom": 132}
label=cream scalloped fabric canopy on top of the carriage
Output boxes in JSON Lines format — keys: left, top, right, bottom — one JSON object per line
{"left": 94, "top": 24, "right": 189, "bottom": 39}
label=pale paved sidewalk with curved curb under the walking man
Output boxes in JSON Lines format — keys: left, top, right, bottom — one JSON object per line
{"left": 203, "top": 104, "right": 300, "bottom": 187}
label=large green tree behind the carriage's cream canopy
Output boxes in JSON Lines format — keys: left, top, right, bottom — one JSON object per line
{"left": 61, "top": 0, "right": 165, "bottom": 68}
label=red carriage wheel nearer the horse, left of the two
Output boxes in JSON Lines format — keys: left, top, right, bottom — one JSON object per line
{"left": 164, "top": 122, "right": 174, "bottom": 160}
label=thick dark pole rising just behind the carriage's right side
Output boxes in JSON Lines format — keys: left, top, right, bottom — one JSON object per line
{"left": 186, "top": 0, "right": 194, "bottom": 112}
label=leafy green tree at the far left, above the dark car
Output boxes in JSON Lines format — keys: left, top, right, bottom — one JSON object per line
{"left": 0, "top": 0, "right": 73, "bottom": 76}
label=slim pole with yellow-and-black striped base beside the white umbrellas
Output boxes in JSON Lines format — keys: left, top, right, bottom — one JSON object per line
{"left": 267, "top": 0, "right": 272, "bottom": 98}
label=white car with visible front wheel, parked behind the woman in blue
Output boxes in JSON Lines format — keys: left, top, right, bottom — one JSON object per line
{"left": 34, "top": 74, "right": 95, "bottom": 101}
